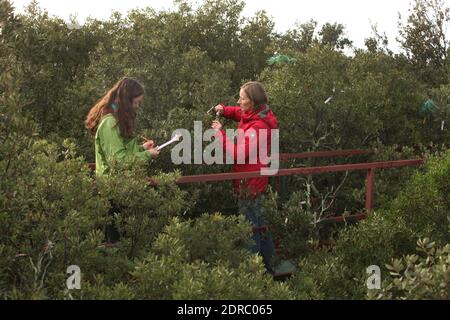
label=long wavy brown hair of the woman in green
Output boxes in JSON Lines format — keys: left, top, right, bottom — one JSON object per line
{"left": 84, "top": 77, "right": 144, "bottom": 138}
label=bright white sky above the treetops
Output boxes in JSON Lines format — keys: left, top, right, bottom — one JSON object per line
{"left": 12, "top": 0, "right": 418, "bottom": 51}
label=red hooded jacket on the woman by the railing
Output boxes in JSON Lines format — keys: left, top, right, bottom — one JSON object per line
{"left": 216, "top": 106, "right": 278, "bottom": 196}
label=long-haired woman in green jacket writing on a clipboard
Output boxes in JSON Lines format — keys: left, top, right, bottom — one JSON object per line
{"left": 85, "top": 77, "right": 159, "bottom": 243}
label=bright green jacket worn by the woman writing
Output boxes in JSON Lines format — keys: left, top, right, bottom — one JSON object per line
{"left": 95, "top": 114, "right": 151, "bottom": 176}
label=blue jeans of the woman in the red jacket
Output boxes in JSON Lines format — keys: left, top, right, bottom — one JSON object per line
{"left": 238, "top": 196, "right": 275, "bottom": 274}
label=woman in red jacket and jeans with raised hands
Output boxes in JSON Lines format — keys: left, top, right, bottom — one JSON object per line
{"left": 211, "top": 82, "right": 278, "bottom": 273}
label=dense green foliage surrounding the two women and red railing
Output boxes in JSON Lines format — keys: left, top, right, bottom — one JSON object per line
{"left": 0, "top": 0, "right": 450, "bottom": 299}
